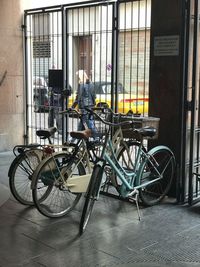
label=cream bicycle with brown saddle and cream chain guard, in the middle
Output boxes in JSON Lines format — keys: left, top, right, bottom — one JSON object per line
{"left": 31, "top": 108, "right": 139, "bottom": 218}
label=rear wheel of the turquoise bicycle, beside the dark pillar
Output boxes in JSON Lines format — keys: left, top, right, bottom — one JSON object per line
{"left": 139, "top": 146, "right": 175, "bottom": 206}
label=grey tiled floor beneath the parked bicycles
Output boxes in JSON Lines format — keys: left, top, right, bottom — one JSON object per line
{"left": 0, "top": 152, "right": 200, "bottom": 267}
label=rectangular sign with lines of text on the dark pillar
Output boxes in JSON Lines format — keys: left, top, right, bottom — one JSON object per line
{"left": 154, "top": 35, "right": 180, "bottom": 56}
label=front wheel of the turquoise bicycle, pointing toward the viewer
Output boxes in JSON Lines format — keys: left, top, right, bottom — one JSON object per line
{"left": 79, "top": 164, "right": 103, "bottom": 235}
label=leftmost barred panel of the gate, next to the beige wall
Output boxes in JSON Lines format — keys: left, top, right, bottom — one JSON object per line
{"left": 25, "top": 10, "right": 63, "bottom": 146}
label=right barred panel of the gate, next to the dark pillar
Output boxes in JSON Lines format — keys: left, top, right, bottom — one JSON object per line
{"left": 117, "top": 1, "right": 151, "bottom": 114}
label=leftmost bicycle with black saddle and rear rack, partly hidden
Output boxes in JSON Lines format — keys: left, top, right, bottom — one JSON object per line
{"left": 8, "top": 127, "right": 57, "bottom": 206}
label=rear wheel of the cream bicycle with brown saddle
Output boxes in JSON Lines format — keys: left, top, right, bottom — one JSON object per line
{"left": 32, "top": 152, "right": 86, "bottom": 218}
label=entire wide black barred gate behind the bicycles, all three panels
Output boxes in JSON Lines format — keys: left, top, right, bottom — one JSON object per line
{"left": 25, "top": 0, "right": 151, "bottom": 147}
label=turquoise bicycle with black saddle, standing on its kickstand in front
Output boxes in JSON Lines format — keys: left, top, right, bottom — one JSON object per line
{"left": 79, "top": 110, "right": 175, "bottom": 235}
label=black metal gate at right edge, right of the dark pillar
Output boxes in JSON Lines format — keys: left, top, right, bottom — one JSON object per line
{"left": 181, "top": 0, "right": 200, "bottom": 205}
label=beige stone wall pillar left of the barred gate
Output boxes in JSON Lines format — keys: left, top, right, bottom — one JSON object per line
{"left": 0, "top": 0, "right": 24, "bottom": 151}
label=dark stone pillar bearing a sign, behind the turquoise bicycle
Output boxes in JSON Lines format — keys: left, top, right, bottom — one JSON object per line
{"left": 149, "top": 0, "right": 185, "bottom": 196}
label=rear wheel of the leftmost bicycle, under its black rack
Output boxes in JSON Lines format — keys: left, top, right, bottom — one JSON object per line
{"left": 8, "top": 149, "right": 43, "bottom": 206}
